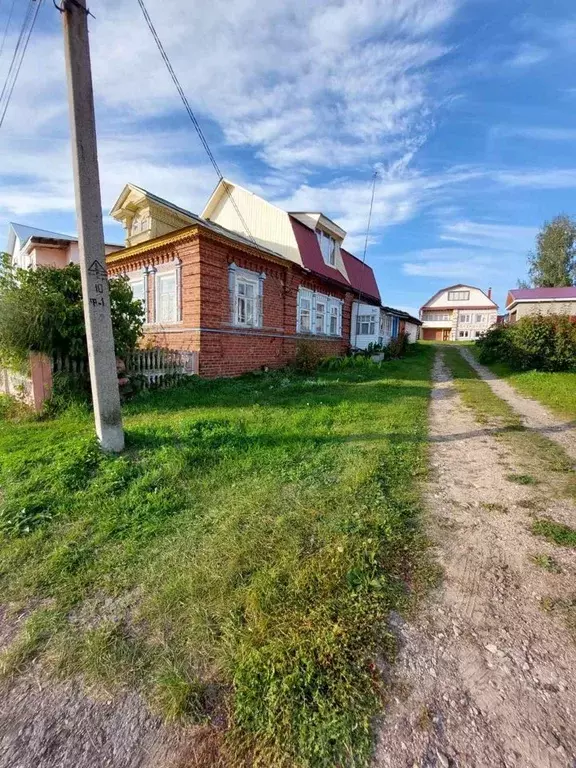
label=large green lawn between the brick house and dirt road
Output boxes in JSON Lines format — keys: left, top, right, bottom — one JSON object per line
{"left": 0, "top": 346, "right": 434, "bottom": 768}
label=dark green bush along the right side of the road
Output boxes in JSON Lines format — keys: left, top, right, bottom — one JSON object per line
{"left": 477, "top": 315, "right": 576, "bottom": 371}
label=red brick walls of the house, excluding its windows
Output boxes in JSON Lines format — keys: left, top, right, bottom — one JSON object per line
{"left": 109, "top": 230, "right": 353, "bottom": 377}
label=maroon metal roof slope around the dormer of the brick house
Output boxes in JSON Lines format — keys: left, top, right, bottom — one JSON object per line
{"left": 290, "top": 216, "right": 380, "bottom": 303}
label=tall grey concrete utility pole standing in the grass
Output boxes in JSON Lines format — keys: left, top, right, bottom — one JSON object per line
{"left": 62, "top": 0, "right": 124, "bottom": 453}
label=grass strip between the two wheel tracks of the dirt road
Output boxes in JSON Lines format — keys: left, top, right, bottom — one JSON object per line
{"left": 442, "top": 348, "right": 576, "bottom": 507}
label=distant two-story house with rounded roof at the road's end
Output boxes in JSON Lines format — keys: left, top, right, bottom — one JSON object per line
{"left": 420, "top": 284, "right": 498, "bottom": 341}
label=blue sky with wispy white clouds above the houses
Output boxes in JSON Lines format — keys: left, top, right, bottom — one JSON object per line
{"left": 0, "top": 0, "right": 576, "bottom": 313}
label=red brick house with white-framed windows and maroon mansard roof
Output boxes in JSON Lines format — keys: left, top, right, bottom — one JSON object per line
{"left": 106, "top": 181, "right": 380, "bottom": 376}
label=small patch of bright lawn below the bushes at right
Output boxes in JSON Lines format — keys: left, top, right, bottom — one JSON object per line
{"left": 471, "top": 347, "right": 576, "bottom": 418}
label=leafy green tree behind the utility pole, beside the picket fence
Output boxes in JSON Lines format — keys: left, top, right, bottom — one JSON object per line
{"left": 0, "top": 254, "right": 144, "bottom": 367}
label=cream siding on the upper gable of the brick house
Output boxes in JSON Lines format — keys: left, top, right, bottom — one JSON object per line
{"left": 202, "top": 184, "right": 302, "bottom": 265}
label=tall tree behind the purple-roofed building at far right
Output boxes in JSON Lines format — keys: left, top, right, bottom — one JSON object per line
{"left": 528, "top": 214, "right": 576, "bottom": 288}
